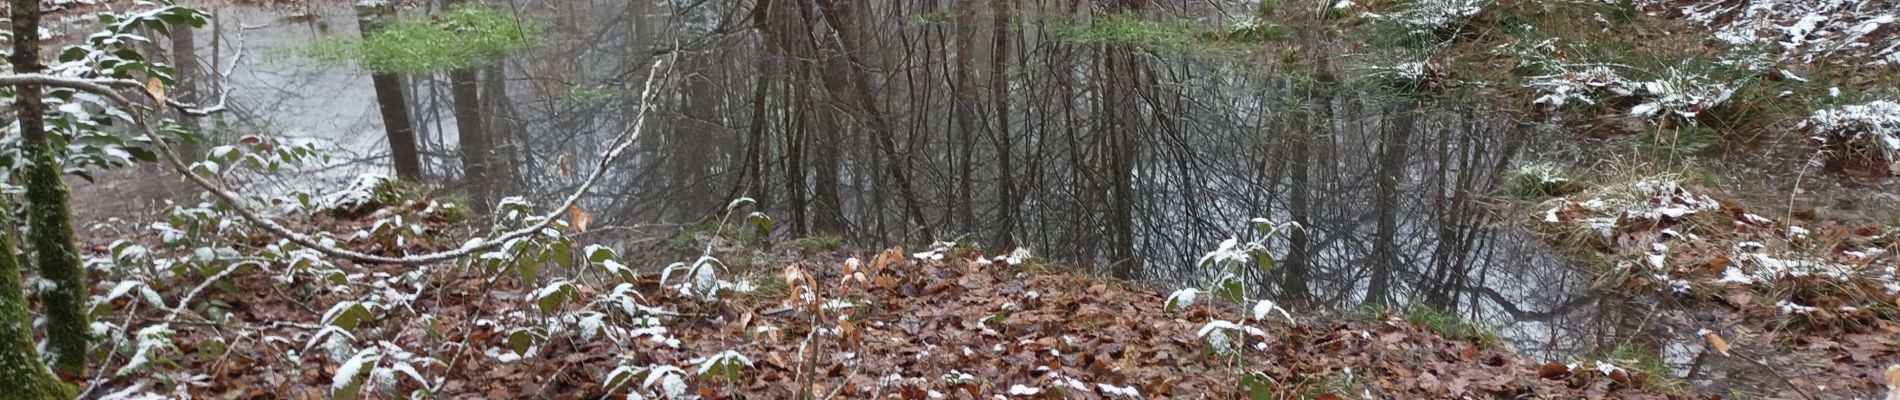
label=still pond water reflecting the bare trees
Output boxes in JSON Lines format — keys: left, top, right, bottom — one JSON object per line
{"left": 77, "top": 0, "right": 1695, "bottom": 369}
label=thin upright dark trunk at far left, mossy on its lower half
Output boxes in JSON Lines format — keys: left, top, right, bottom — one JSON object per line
{"left": 8, "top": 0, "right": 91, "bottom": 375}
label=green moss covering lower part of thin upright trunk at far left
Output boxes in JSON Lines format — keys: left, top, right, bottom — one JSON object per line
{"left": 23, "top": 140, "right": 91, "bottom": 375}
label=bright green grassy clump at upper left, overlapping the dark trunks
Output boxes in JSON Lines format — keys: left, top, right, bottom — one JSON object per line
{"left": 310, "top": 6, "right": 542, "bottom": 74}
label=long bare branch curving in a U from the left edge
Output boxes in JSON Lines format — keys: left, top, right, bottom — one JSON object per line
{"left": 0, "top": 61, "right": 665, "bottom": 265}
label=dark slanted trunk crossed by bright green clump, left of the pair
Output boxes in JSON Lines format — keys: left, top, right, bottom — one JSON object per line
{"left": 357, "top": 4, "right": 422, "bottom": 182}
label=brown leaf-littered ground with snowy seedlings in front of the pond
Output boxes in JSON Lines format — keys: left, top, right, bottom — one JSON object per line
{"left": 70, "top": 191, "right": 1664, "bottom": 398}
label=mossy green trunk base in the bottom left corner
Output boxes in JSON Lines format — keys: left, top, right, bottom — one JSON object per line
{"left": 0, "top": 195, "right": 78, "bottom": 400}
